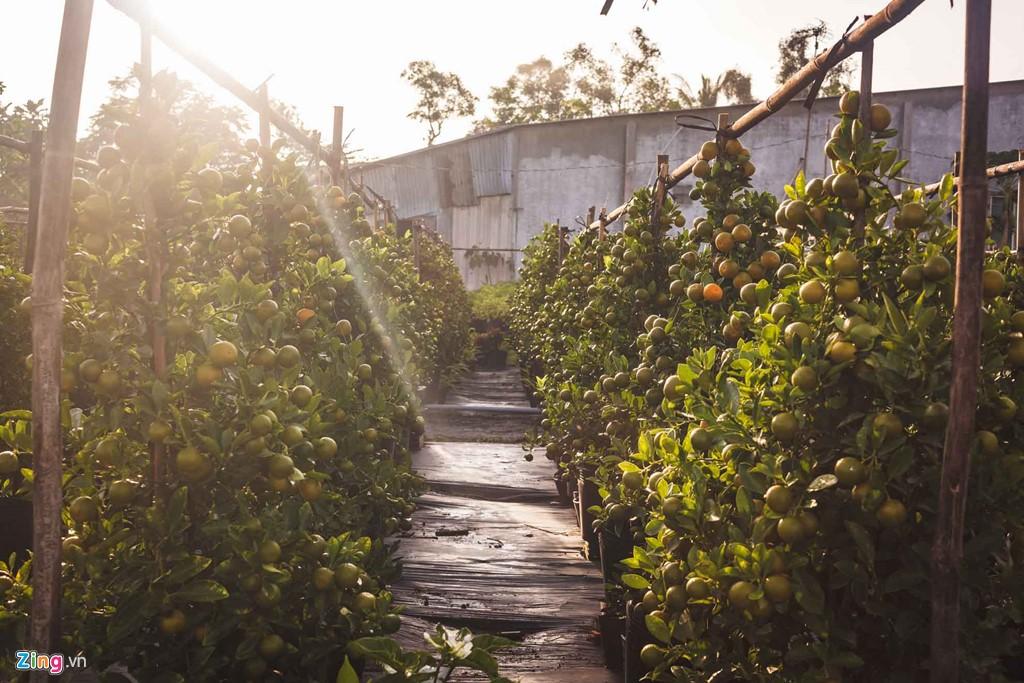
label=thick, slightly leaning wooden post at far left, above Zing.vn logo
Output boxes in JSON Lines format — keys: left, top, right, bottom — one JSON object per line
{"left": 28, "top": 0, "right": 92, "bottom": 671}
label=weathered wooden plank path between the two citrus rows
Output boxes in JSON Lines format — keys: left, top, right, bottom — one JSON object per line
{"left": 394, "top": 371, "right": 617, "bottom": 683}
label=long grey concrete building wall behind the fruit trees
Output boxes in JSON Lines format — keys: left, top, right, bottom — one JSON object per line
{"left": 354, "top": 81, "right": 1024, "bottom": 289}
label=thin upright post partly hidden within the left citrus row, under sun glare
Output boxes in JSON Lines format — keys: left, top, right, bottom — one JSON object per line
{"left": 138, "top": 7, "right": 167, "bottom": 499}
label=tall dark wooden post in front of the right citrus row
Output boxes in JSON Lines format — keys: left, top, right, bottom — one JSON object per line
{"left": 931, "top": 0, "right": 992, "bottom": 683}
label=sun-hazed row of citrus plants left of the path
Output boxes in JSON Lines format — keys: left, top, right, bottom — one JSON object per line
{"left": 0, "top": 74, "right": 507, "bottom": 683}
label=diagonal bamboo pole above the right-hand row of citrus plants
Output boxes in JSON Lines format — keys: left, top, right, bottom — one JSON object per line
{"left": 595, "top": 0, "right": 925, "bottom": 227}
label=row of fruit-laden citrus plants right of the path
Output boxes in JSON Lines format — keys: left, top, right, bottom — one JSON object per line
{"left": 511, "top": 92, "right": 1024, "bottom": 683}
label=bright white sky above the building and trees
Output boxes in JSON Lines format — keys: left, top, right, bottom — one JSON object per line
{"left": 0, "top": 0, "right": 1024, "bottom": 157}
